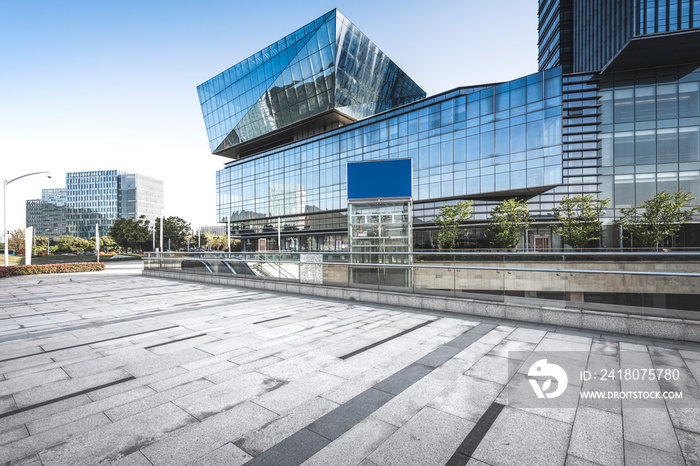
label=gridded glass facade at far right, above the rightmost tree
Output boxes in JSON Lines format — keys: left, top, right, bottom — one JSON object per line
{"left": 598, "top": 65, "right": 700, "bottom": 217}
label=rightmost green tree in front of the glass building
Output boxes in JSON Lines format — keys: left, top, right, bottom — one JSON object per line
{"left": 619, "top": 190, "right": 700, "bottom": 249}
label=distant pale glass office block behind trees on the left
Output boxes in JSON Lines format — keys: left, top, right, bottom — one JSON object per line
{"left": 27, "top": 170, "right": 163, "bottom": 238}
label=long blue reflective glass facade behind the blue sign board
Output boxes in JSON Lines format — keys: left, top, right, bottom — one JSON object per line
{"left": 217, "top": 68, "right": 562, "bottom": 240}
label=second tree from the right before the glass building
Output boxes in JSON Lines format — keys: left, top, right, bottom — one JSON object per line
{"left": 552, "top": 194, "right": 610, "bottom": 249}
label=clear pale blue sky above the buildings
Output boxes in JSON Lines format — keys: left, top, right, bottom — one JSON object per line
{"left": 0, "top": 0, "right": 537, "bottom": 233}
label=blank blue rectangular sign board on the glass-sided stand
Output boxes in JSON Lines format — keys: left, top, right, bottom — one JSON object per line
{"left": 348, "top": 159, "right": 413, "bottom": 199}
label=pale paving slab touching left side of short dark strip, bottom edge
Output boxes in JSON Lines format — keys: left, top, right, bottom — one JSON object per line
{"left": 368, "top": 408, "right": 474, "bottom": 466}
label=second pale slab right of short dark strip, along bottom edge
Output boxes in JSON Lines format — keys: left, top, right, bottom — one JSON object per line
{"left": 569, "top": 406, "right": 624, "bottom": 466}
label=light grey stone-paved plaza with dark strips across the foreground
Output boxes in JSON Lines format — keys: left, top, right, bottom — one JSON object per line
{"left": 0, "top": 262, "right": 700, "bottom": 466}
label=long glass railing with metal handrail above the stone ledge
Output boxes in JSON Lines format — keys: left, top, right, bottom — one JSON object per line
{"left": 145, "top": 251, "right": 700, "bottom": 319}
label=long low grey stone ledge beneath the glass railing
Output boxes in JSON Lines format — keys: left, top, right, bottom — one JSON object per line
{"left": 143, "top": 270, "right": 700, "bottom": 342}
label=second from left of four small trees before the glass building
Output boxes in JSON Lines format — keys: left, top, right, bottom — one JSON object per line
{"left": 486, "top": 199, "right": 532, "bottom": 248}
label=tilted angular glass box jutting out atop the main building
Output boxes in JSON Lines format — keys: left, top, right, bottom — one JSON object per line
{"left": 197, "top": 10, "right": 425, "bottom": 153}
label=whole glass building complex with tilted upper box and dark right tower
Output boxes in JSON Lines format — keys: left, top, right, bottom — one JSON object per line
{"left": 198, "top": 5, "right": 700, "bottom": 251}
